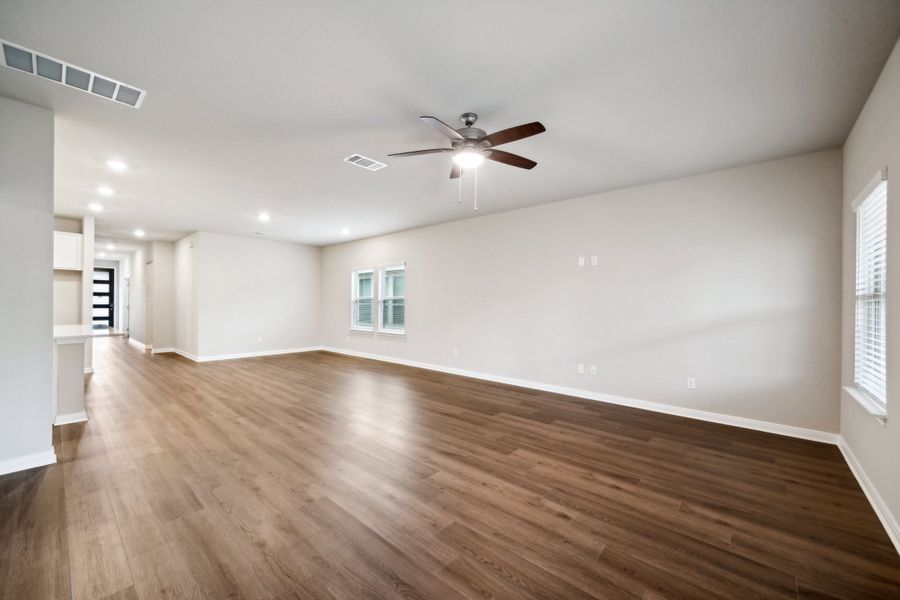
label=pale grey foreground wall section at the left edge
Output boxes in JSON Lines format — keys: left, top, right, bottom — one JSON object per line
{"left": 0, "top": 97, "right": 55, "bottom": 473}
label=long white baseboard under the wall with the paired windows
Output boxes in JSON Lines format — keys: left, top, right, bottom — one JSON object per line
{"left": 322, "top": 346, "right": 838, "bottom": 444}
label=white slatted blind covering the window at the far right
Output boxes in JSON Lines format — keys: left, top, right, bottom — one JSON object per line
{"left": 854, "top": 179, "right": 887, "bottom": 408}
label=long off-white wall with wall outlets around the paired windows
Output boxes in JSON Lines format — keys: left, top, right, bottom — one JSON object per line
{"left": 324, "top": 150, "right": 841, "bottom": 432}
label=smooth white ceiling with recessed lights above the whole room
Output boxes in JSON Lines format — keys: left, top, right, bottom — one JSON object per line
{"left": 0, "top": 0, "right": 900, "bottom": 244}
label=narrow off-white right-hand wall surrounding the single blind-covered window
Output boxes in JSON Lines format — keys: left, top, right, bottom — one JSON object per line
{"left": 841, "top": 41, "right": 900, "bottom": 544}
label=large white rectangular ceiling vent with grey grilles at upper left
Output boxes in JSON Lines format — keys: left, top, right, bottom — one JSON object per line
{"left": 0, "top": 40, "right": 147, "bottom": 108}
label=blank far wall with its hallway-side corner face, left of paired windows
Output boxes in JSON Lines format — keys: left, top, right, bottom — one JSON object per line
{"left": 174, "top": 232, "right": 322, "bottom": 359}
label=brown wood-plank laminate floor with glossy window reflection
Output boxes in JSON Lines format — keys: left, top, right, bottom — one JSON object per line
{"left": 0, "top": 338, "right": 900, "bottom": 600}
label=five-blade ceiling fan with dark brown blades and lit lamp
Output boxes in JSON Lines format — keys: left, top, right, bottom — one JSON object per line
{"left": 388, "top": 113, "right": 547, "bottom": 179}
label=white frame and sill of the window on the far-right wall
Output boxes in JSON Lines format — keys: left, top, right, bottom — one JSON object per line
{"left": 844, "top": 169, "right": 889, "bottom": 422}
